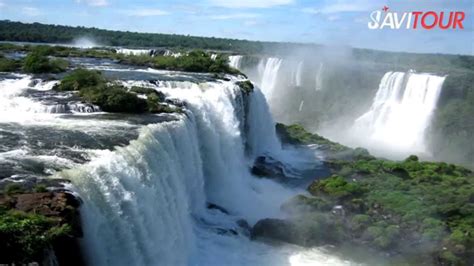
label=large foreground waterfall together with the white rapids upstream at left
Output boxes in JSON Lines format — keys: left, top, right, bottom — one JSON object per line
{"left": 0, "top": 69, "right": 354, "bottom": 266}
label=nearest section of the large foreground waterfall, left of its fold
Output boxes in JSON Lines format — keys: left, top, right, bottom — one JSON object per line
{"left": 63, "top": 121, "right": 205, "bottom": 265}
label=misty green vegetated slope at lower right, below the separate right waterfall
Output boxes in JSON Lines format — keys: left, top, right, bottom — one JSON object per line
{"left": 278, "top": 124, "right": 474, "bottom": 265}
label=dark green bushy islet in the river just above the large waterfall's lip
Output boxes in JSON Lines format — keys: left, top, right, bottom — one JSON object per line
{"left": 54, "top": 69, "right": 180, "bottom": 113}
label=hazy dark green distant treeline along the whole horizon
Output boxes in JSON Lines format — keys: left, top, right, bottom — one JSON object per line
{"left": 0, "top": 20, "right": 474, "bottom": 68}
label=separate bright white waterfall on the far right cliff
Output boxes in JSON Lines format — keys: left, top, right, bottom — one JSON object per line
{"left": 353, "top": 72, "right": 445, "bottom": 156}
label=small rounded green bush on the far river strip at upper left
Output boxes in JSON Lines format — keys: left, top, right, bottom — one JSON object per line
{"left": 23, "top": 47, "right": 69, "bottom": 74}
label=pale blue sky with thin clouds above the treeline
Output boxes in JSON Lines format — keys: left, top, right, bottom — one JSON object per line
{"left": 0, "top": 0, "right": 474, "bottom": 55}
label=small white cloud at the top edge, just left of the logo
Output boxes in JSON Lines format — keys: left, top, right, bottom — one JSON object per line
{"left": 303, "top": 0, "right": 380, "bottom": 14}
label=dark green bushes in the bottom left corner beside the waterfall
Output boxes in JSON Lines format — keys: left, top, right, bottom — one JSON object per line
{"left": 0, "top": 208, "right": 72, "bottom": 264}
